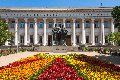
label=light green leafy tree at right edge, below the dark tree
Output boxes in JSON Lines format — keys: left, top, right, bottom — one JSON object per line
{"left": 108, "top": 32, "right": 120, "bottom": 46}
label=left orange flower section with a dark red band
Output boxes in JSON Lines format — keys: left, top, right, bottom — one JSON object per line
{"left": 0, "top": 56, "right": 53, "bottom": 80}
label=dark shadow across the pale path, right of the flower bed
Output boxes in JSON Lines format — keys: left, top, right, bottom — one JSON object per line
{"left": 93, "top": 54, "right": 120, "bottom": 67}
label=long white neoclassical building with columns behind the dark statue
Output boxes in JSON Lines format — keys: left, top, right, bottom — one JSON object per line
{"left": 0, "top": 7, "right": 117, "bottom": 46}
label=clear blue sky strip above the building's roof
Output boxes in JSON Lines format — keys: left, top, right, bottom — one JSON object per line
{"left": 0, "top": 0, "right": 120, "bottom": 7}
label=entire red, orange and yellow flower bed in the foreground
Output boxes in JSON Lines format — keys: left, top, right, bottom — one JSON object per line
{"left": 0, "top": 54, "right": 120, "bottom": 80}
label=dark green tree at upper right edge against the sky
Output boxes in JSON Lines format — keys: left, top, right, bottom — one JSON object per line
{"left": 112, "top": 6, "right": 120, "bottom": 32}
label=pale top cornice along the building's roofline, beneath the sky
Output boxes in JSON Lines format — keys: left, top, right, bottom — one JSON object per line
{"left": 0, "top": 7, "right": 113, "bottom": 12}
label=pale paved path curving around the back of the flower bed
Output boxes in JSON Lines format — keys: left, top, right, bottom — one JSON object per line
{"left": 0, "top": 52, "right": 120, "bottom": 67}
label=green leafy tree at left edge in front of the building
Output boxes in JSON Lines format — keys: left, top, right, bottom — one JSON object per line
{"left": 0, "top": 19, "right": 13, "bottom": 46}
